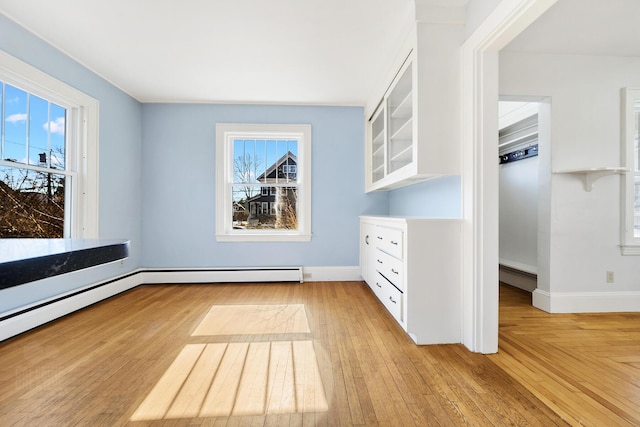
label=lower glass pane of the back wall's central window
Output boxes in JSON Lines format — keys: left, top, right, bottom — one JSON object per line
{"left": 231, "top": 185, "right": 298, "bottom": 230}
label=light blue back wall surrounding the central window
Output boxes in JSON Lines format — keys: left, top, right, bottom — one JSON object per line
{"left": 142, "top": 104, "right": 388, "bottom": 267}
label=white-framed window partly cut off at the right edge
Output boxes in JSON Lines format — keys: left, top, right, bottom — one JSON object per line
{"left": 621, "top": 88, "right": 640, "bottom": 255}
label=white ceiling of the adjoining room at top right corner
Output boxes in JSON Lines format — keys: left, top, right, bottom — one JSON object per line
{"left": 505, "top": 0, "right": 640, "bottom": 56}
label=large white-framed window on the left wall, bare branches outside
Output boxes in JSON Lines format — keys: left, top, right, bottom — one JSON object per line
{"left": 0, "top": 52, "right": 98, "bottom": 238}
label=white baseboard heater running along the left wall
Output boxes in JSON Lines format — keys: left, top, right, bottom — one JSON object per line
{"left": 0, "top": 274, "right": 141, "bottom": 341}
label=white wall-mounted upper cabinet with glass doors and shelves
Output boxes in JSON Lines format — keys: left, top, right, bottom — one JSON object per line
{"left": 365, "top": 23, "right": 460, "bottom": 191}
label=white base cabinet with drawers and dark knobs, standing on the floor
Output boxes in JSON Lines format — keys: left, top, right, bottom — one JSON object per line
{"left": 360, "top": 216, "right": 462, "bottom": 344}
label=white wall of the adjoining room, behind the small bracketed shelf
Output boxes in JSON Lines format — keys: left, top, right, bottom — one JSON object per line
{"left": 500, "top": 52, "right": 640, "bottom": 311}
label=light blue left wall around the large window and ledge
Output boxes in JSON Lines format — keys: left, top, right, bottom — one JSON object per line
{"left": 0, "top": 14, "right": 142, "bottom": 312}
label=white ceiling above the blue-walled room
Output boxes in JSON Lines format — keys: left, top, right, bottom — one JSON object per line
{"left": 0, "top": 0, "right": 413, "bottom": 105}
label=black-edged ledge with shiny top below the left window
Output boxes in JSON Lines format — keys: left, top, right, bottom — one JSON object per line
{"left": 0, "top": 239, "right": 129, "bottom": 289}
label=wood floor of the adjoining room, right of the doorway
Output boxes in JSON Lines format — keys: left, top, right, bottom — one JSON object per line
{"left": 488, "top": 286, "right": 640, "bottom": 426}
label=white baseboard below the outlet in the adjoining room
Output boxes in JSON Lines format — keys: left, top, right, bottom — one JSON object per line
{"left": 533, "top": 289, "right": 640, "bottom": 313}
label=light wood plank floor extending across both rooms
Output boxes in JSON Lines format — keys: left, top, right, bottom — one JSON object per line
{"left": 0, "top": 282, "right": 640, "bottom": 427}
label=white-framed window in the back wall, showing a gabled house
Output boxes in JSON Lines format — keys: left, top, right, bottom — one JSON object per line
{"left": 216, "top": 123, "right": 311, "bottom": 241}
